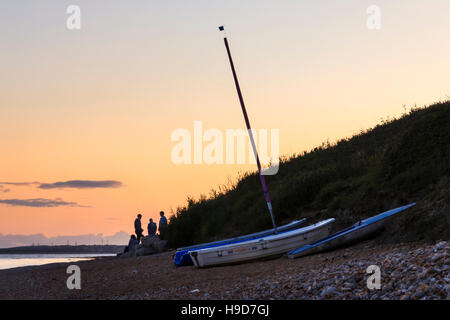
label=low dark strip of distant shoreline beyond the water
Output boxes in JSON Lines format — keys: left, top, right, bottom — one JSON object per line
{"left": 0, "top": 245, "right": 125, "bottom": 255}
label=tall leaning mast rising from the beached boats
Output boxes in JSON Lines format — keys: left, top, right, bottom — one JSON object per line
{"left": 219, "top": 26, "right": 277, "bottom": 233}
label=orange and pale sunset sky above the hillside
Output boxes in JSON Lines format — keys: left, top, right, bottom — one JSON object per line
{"left": 0, "top": 0, "right": 450, "bottom": 237}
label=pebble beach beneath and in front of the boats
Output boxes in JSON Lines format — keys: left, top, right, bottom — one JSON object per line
{"left": 0, "top": 240, "right": 450, "bottom": 300}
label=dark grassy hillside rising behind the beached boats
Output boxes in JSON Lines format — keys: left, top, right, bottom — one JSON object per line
{"left": 168, "top": 101, "right": 450, "bottom": 247}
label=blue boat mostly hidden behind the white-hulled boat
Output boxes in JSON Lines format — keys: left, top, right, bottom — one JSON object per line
{"left": 174, "top": 219, "right": 306, "bottom": 267}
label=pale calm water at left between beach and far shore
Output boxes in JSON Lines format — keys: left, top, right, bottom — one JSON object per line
{"left": 0, "top": 253, "right": 115, "bottom": 270}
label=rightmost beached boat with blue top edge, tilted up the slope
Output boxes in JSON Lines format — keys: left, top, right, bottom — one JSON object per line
{"left": 287, "top": 203, "right": 415, "bottom": 259}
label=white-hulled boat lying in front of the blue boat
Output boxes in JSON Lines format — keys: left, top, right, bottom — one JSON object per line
{"left": 189, "top": 218, "right": 334, "bottom": 267}
